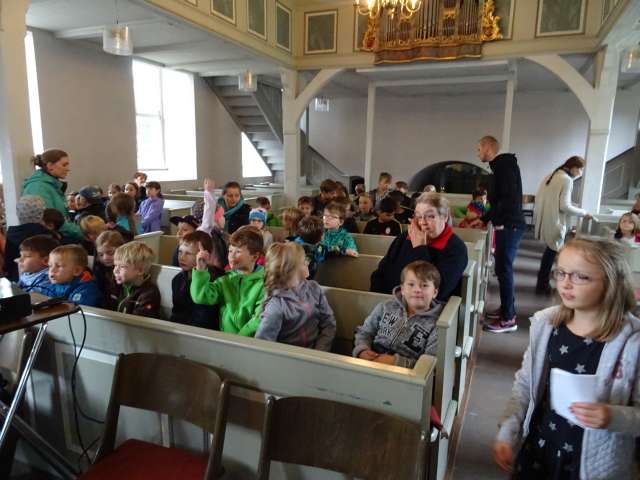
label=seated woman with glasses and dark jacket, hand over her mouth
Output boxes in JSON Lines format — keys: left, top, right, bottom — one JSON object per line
{"left": 370, "top": 192, "right": 468, "bottom": 301}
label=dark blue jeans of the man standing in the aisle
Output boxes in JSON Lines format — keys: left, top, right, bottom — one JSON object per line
{"left": 494, "top": 225, "right": 524, "bottom": 320}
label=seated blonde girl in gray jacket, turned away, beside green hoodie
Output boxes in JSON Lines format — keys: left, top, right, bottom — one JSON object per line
{"left": 256, "top": 242, "right": 336, "bottom": 352}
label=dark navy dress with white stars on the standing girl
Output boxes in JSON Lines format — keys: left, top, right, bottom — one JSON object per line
{"left": 513, "top": 324, "right": 604, "bottom": 480}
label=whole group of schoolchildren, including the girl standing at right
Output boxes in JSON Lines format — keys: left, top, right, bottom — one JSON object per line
{"left": 2, "top": 171, "right": 640, "bottom": 478}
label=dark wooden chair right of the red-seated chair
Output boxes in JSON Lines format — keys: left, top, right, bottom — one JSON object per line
{"left": 258, "top": 397, "right": 427, "bottom": 480}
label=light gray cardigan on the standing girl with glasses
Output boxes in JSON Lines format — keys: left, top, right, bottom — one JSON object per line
{"left": 496, "top": 306, "right": 640, "bottom": 480}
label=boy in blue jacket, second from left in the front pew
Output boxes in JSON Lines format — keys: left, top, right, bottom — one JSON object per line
{"left": 48, "top": 245, "right": 103, "bottom": 307}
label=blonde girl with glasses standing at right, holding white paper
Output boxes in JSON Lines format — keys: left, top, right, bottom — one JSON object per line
{"left": 494, "top": 238, "right": 640, "bottom": 479}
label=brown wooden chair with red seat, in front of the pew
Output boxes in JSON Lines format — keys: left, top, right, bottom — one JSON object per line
{"left": 80, "top": 353, "right": 229, "bottom": 480}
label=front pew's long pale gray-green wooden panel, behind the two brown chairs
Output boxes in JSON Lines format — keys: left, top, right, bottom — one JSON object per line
{"left": 40, "top": 307, "right": 436, "bottom": 479}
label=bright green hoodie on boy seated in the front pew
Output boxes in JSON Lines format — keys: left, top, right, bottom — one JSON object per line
{"left": 190, "top": 267, "right": 264, "bottom": 337}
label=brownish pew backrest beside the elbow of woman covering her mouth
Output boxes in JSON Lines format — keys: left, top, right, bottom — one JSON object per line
{"left": 314, "top": 255, "right": 382, "bottom": 291}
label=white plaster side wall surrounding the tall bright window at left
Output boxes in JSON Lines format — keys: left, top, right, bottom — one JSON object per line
{"left": 28, "top": 31, "right": 242, "bottom": 191}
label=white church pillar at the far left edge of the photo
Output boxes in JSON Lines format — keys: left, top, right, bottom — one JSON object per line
{"left": 0, "top": 0, "right": 34, "bottom": 225}
